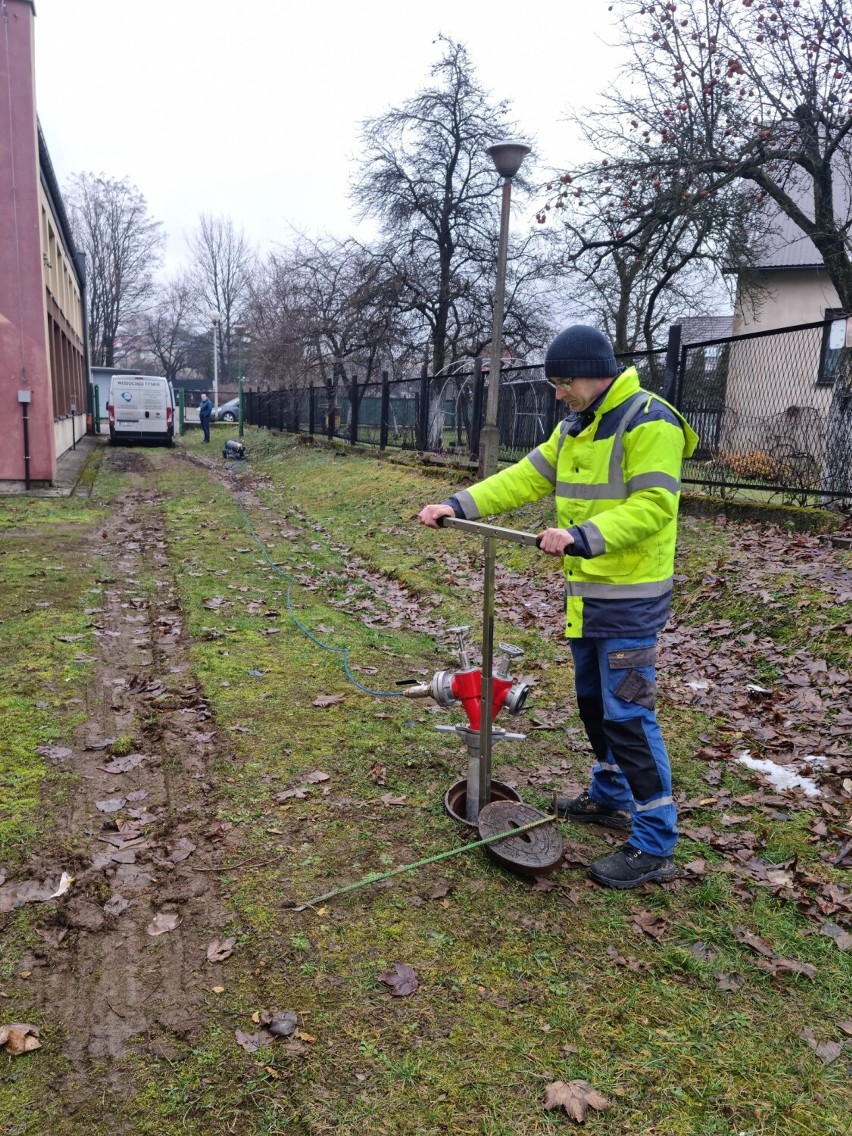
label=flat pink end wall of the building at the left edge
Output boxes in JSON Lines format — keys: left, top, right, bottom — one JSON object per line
{"left": 0, "top": 0, "right": 56, "bottom": 482}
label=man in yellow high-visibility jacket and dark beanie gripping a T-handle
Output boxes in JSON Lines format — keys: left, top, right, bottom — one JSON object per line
{"left": 419, "top": 324, "right": 698, "bottom": 887}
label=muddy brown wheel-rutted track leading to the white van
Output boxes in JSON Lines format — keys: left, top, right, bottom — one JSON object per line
{"left": 17, "top": 451, "right": 233, "bottom": 1099}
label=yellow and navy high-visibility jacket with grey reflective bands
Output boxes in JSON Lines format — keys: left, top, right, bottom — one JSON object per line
{"left": 454, "top": 367, "right": 699, "bottom": 638}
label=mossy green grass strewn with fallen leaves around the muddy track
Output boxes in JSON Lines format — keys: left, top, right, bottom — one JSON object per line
{"left": 0, "top": 429, "right": 852, "bottom": 1136}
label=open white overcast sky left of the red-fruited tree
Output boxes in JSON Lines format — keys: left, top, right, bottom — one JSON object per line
{"left": 35, "top": 0, "right": 619, "bottom": 269}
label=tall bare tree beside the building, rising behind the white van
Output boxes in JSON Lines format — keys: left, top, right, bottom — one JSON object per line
{"left": 64, "top": 174, "right": 165, "bottom": 367}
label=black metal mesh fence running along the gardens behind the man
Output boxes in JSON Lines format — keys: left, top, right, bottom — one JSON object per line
{"left": 240, "top": 317, "right": 852, "bottom": 504}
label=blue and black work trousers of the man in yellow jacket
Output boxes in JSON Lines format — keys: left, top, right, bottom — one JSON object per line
{"left": 569, "top": 635, "right": 677, "bottom": 855}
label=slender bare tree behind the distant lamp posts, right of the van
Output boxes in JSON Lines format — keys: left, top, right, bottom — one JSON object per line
{"left": 187, "top": 214, "right": 256, "bottom": 379}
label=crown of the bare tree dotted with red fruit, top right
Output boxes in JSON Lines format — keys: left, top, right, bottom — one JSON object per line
{"left": 547, "top": 0, "right": 852, "bottom": 310}
